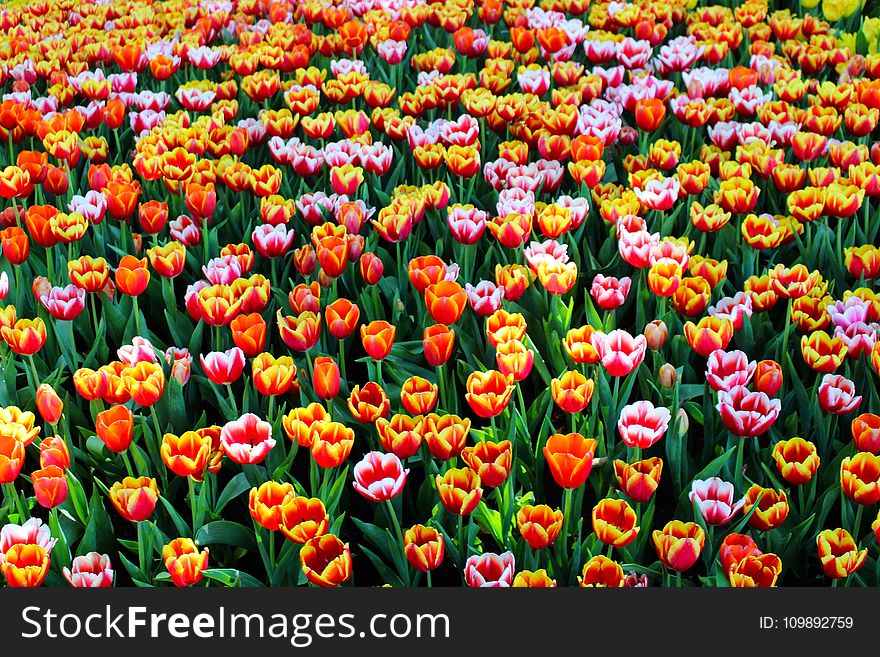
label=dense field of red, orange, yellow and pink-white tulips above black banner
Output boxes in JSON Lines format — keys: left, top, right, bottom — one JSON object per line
{"left": 0, "top": 0, "right": 880, "bottom": 587}
